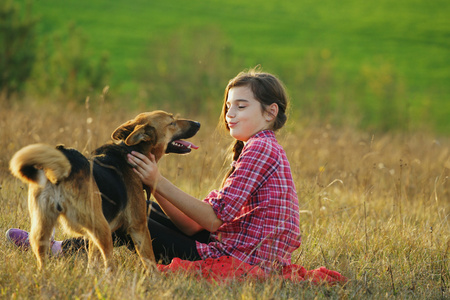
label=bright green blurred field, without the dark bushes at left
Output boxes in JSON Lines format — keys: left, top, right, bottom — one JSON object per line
{"left": 21, "top": 0, "right": 450, "bottom": 133}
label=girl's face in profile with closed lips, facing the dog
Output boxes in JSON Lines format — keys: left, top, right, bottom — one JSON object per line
{"left": 225, "top": 86, "right": 276, "bottom": 142}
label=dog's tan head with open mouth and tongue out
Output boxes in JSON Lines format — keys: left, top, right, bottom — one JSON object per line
{"left": 111, "top": 110, "right": 200, "bottom": 160}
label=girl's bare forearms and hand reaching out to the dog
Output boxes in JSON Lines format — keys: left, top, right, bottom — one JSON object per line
{"left": 128, "top": 151, "right": 223, "bottom": 234}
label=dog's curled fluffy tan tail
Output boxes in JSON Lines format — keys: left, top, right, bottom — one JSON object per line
{"left": 9, "top": 144, "right": 71, "bottom": 186}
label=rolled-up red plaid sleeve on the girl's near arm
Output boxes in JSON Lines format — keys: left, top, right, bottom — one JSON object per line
{"left": 204, "top": 139, "right": 280, "bottom": 222}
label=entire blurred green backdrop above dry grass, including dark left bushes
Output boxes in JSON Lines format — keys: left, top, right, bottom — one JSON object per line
{"left": 0, "top": 0, "right": 450, "bottom": 135}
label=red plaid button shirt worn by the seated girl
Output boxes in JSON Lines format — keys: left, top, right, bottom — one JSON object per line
{"left": 197, "top": 130, "right": 300, "bottom": 271}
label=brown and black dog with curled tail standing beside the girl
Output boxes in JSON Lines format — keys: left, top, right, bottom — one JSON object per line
{"left": 10, "top": 111, "right": 200, "bottom": 271}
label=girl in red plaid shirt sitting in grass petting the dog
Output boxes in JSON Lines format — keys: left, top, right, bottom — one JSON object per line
{"left": 7, "top": 70, "right": 300, "bottom": 271}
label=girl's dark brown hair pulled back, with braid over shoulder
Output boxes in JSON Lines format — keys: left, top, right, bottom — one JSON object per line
{"left": 221, "top": 68, "right": 289, "bottom": 185}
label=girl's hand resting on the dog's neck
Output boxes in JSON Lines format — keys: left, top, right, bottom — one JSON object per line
{"left": 127, "top": 151, "right": 159, "bottom": 187}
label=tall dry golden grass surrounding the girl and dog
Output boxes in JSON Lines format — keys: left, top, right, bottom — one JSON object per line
{"left": 0, "top": 99, "right": 450, "bottom": 299}
